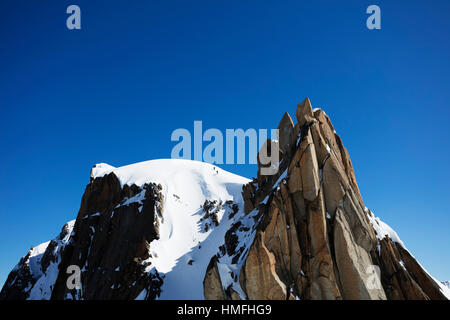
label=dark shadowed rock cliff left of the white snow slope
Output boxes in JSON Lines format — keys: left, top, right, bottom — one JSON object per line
{"left": 0, "top": 173, "right": 163, "bottom": 300}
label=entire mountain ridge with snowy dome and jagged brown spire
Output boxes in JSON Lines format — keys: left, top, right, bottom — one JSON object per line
{"left": 0, "top": 98, "right": 450, "bottom": 300}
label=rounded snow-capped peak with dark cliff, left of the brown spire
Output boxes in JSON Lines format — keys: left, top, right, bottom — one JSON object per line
{"left": 0, "top": 159, "right": 250, "bottom": 299}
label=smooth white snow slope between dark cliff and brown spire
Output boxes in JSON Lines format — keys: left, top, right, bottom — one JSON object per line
{"left": 91, "top": 159, "right": 250, "bottom": 299}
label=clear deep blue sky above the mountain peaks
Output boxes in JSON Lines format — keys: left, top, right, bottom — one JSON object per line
{"left": 0, "top": 0, "right": 450, "bottom": 284}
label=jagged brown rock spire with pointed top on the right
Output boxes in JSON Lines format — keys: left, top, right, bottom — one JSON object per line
{"left": 205, "top": 98, "right": 446, "bottom": 300}
